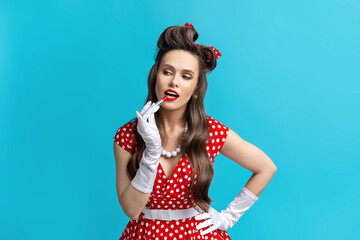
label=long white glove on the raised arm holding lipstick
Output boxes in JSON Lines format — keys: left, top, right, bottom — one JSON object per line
{"left": 131, "top": 101, "right": 162, "bottom": 193}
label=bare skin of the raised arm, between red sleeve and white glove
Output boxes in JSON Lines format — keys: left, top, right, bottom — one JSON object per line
{"left": 114, "top": 142, "right": 150, "bottom": 220}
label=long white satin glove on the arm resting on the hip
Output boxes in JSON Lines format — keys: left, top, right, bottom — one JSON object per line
{"left": 195, "top": 187, "right": 258, "bottom": 235}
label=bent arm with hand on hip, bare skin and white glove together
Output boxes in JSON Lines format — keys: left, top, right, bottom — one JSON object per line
{"left": 195, "top": 129, "right": 277, "bottom": 235}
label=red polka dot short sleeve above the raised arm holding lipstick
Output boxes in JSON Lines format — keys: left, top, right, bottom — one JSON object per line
{"left": 113, "top": 120, "right": 136, "bottom": 154}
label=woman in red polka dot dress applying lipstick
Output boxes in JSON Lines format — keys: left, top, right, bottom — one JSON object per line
{"left": 114, "top": 23, "right": 276, "bottom": 240}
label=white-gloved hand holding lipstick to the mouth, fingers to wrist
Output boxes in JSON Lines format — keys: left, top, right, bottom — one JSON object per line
{"left": 136, "top": 101, "right": 162, "bottom": 153}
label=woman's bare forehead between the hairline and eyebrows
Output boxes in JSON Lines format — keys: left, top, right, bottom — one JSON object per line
{"left": 160, "top": 50, "right": 199, "bottom": 74}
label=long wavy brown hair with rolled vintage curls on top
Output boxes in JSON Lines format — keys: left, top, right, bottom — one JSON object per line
{"left": 127, "top": 26, "right": 216, "bottom": 212}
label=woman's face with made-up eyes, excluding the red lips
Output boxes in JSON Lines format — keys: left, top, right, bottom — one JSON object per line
{"left": 155, "top": 49, "right": 199, "bottom": 110}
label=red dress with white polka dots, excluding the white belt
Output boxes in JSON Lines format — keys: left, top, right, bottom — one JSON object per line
{"left": 114, "top": 116, "right": 230, "bottom": 240}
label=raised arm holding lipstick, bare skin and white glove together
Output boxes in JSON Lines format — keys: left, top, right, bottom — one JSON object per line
{"left": 114, "top": 101, "right": 161, "bottom": 220}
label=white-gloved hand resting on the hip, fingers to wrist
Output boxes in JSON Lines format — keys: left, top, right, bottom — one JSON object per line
{"left": 195, "top": 207, "right": 229, "bottom": 235}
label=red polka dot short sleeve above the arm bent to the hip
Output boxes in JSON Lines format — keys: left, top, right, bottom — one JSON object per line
{"left": 206, "top": 116, "right": 229, "bottom": 163}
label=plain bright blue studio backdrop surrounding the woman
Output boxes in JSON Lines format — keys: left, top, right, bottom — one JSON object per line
{"left": 0, "top": 0, "right": 360, "bottom": 240}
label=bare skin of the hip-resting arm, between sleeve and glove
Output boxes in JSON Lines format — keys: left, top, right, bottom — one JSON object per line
{"left": 220, "top": 129, "right": 277, "bottom": 196}
